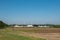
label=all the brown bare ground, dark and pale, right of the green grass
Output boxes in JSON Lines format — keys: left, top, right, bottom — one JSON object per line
{"left": 10, "top": 28, "right": 60, "bottom": 40}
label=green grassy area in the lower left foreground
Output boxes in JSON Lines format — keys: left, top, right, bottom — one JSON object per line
{"left": 0, "top": 29, "right": 45, "bottom": 40}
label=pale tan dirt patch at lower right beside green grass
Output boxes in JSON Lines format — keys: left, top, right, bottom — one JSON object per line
{"left": 20, "top": 32, "right": 60, "bottom": 40}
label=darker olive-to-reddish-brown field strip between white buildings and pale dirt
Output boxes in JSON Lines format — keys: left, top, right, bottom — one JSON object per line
{"left": 12, "top": 28, "right": 60, "bottom": 33}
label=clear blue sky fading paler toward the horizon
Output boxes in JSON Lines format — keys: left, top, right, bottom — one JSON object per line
{"left": 0, "top": 0, "right": 60, "bottom": 24}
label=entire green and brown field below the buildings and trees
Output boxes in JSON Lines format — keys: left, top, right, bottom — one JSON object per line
{"left": 0, "top": 28, "right": 60, "bottom": 40}
